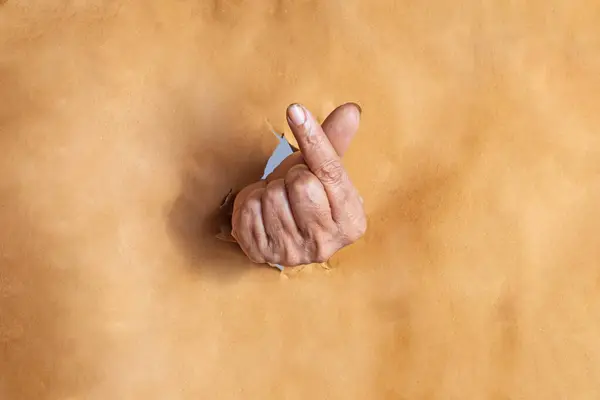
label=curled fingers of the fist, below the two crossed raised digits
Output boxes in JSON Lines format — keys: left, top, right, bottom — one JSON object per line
{"left": 232, "top": 164, "right": 345, "bottom": 266}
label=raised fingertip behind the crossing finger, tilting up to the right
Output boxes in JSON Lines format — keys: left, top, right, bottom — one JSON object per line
{"left": 321, "top": 103, "right": 362, "bottom": 158}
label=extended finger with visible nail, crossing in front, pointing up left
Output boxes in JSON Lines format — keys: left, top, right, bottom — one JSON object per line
{"left": 287, "top": 104, "right": 358, "bottom": 222}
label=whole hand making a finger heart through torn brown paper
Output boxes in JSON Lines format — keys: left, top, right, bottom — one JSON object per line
{"left": 232, "top": 103, "right": 367, "bottom": 266}
